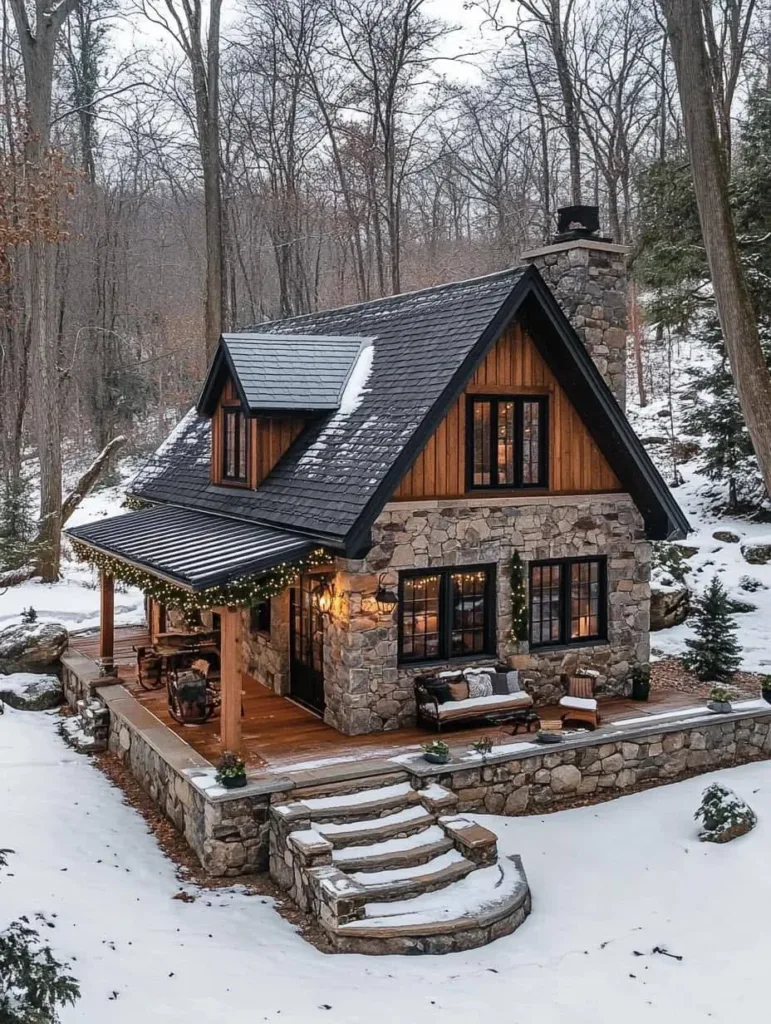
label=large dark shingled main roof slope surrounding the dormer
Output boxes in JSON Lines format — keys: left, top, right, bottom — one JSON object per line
{"left": 131, "top": 269, "right": 524, "bottom": 544}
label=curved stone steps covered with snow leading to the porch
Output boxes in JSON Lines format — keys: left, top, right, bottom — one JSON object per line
{"left": 270, "top": 772, "right": 530, "bottom": 953}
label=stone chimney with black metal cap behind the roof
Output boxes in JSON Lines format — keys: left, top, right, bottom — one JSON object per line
{"left": 521, "top": 206, "right": 629, "bottom": 409}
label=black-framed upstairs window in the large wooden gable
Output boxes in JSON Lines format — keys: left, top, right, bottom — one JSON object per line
{"left": 466, "top": 395, "right": 549, "bottom": 489}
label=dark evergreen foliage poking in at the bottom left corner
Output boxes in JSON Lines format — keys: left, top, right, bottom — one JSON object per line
{"left": 0, "top": 850, "right": 80, "bottom": 1024}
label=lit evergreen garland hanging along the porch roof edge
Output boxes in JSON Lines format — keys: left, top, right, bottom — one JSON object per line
{"left": 72, "top": 540, "right": 332, "bottom": 614}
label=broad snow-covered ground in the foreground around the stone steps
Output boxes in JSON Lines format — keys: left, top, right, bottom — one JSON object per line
{"left": 0, "top": 712, "right": 771, "bottom": 1024}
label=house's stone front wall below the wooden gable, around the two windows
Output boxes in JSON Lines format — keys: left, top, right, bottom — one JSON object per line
{"left": 325, "top": 495, "right": 650, "bottom": 734}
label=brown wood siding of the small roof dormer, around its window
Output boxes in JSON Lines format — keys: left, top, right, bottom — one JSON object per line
{"left": 210, "top": 374, "right": 305, "bottom": 489}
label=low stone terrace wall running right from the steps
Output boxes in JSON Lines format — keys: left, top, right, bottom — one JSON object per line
{"left": 423, "top": 712, "right": 771, "bottom": 815}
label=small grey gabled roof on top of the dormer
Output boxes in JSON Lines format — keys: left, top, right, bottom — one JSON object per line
{"left": 198, "top": 331, "right": 372, "bottom": 416}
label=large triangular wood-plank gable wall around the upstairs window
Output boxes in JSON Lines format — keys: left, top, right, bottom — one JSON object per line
{"left": 391, "top": 324, "right": 624, "bottom": 501}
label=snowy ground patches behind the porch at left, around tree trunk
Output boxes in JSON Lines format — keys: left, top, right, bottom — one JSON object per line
{"left": 0, "top": 460, "right": 144, "bottom": 631}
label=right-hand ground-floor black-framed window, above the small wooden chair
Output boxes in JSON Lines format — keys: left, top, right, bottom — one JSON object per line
{"left": 530, "top": 558, "right": 607, "bottom": 647}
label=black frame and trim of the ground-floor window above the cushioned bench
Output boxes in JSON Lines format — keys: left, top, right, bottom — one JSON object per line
{"left": 397, "top": 562, "right": 498, "bottom": 666}
